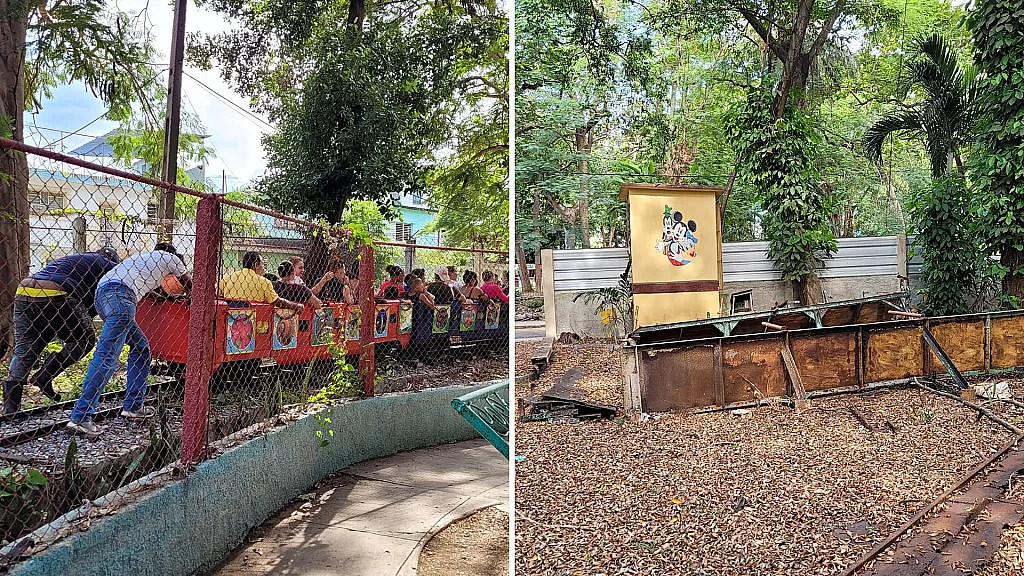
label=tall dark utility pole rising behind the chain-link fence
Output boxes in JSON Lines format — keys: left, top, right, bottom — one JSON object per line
{"left": 158, "top": 0, "right": 188, "bottom": 241}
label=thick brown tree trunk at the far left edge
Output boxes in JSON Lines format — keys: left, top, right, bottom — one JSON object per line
{"left": 0, "top": 6, "right": 30, "bottom": 358}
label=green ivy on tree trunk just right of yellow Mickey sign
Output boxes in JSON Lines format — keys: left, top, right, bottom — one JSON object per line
{"left": 726, "top": 87, "right": 836, "bottom": 303}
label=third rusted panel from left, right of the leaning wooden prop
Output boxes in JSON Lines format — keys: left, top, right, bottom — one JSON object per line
{"left": 790, "top": 332, "right": 858, "bottom": 390}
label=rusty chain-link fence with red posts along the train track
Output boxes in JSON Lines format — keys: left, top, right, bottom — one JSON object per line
{"left": 0, "top": 138, "right": 510, "bottom": 549}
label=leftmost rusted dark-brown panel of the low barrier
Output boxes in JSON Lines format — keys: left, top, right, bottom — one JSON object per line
{"left": 640, "top": 345, "right": 715, "bottom": 412}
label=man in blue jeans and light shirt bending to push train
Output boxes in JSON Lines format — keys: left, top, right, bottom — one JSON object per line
{"left": 68, "top": 243, "right": 191, "bottom": 438}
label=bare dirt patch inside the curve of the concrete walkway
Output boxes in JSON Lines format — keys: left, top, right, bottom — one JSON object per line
{"left": 416, "top": 508, "right": 509, "bottom": 576}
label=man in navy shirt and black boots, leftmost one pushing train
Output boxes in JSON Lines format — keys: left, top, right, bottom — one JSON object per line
{"left": 3, "top": 248, "right": 120, "bottom": 415}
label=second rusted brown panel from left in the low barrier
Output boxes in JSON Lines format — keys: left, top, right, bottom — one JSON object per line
{"left": 722, "top": 336, "right": 785, "bottom": 404}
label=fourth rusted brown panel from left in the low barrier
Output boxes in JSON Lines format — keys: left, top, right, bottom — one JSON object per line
{"left": 864, "top": 326, "right": 924, "bottom": 382}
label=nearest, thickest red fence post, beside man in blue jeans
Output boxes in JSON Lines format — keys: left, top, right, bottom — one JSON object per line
{"left": 181, "top": 198, "right": 221, "bottom": 463}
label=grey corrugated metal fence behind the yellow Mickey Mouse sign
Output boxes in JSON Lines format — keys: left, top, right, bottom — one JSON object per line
{"left": 552, "top": 236, "right": 901, "bottom": 292}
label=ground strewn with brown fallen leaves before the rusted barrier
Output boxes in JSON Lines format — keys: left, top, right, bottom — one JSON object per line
{"left": 515, "top": 346, "right": 1011, "bottom": 575}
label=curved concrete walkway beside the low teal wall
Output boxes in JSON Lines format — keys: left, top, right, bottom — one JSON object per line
{"left": 215, "top": 440, "right": 509, "bottom": 576}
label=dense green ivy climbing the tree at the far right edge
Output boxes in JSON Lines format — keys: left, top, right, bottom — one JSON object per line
{"left": 969, "top": 0, "right": 1024, "bottom": 306}
